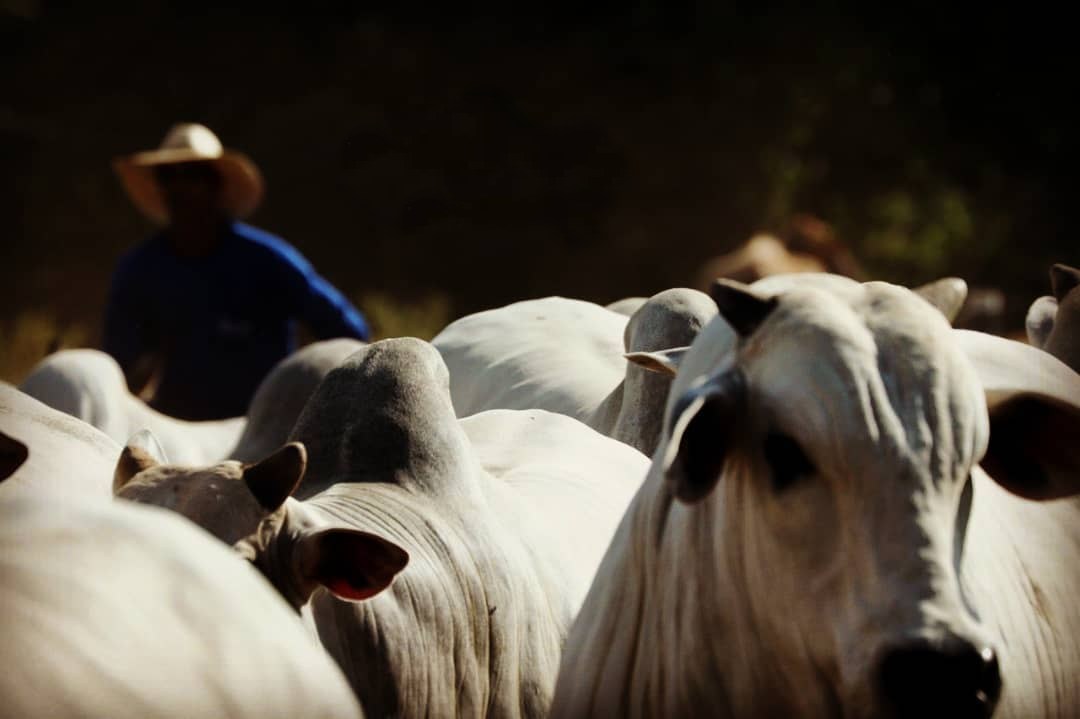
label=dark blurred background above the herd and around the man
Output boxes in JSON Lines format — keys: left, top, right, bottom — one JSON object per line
{"left": 0, "top": 0, "right": 1080, "bottom": 380}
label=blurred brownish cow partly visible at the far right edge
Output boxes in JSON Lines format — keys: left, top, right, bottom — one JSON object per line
{"left": 1025, "top": 263, "right": 1080, "bottom": 371}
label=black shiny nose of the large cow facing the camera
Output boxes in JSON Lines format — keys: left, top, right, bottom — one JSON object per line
{"left": 878, "top": 639, "right": 1001, "bottom": 717}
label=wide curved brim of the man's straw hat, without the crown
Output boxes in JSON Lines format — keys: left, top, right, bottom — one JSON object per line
{"left": 112, "top": 148, "right": 262, "bottom": 225}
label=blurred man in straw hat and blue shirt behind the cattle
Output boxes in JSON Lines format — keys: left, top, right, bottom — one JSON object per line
{"left": 105, "top": 124, "right": 369, "bottom": 420}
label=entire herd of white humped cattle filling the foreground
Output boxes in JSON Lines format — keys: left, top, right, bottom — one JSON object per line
{"left": 0, "top": 264, "right": 1080, "bottom": 719}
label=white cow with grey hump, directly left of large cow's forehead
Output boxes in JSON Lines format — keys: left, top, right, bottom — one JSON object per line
{"left": 432, "top": 288, "right": 716, "bottom": 455}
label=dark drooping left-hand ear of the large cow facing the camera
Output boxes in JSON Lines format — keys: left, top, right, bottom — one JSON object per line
{"left": 662, "top": 369, "right": 746, "bottom": 503}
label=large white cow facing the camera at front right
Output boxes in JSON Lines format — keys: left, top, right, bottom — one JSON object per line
{"left": 552, "top": 275, "right": 1080, "bottom": 718}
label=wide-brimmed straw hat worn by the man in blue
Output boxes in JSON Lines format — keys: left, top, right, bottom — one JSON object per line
{"left": 112, "top": 122, "right": 262, "bottom": 225}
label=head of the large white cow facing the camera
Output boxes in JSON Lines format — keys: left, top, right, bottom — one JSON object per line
{"left": 656, "top": 276, "right": 1080, "bottom": 716}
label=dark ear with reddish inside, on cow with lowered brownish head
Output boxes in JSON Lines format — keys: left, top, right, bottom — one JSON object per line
{"left": 294, "top": 529, "right": 409, "bottom": 601}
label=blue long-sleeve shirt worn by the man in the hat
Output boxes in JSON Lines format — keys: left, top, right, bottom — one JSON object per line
{"left": 105, "top": 221, "right": 370, "bottom": 419}
